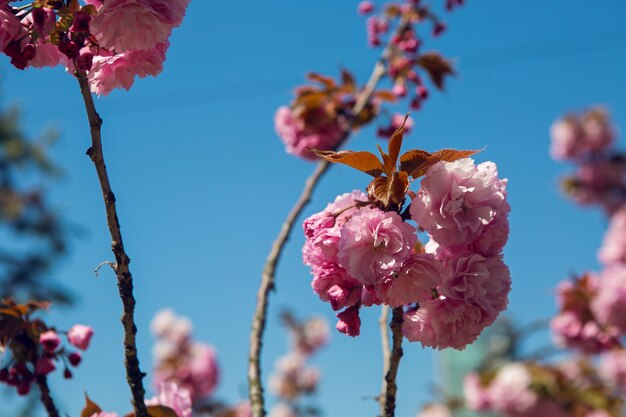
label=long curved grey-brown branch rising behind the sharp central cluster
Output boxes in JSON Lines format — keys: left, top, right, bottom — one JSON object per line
{"left": 248, "top": 21, "right": 409, "bottom": 417}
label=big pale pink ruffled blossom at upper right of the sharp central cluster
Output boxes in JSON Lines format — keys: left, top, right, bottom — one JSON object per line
{"left": 411, "top": 158, "right": 510, "bottom": 249}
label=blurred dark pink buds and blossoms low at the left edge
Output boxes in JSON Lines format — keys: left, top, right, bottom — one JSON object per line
{"left": 0, "top": 324, "right": 93, "bottom": 395}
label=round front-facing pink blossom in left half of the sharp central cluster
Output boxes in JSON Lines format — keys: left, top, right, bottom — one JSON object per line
{"left": 338, "top": 207, "right": 417, "bottom": 285}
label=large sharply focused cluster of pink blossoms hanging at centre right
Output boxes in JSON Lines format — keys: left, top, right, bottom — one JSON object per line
{"left": 303, "top": 158, "right": 511, "bottom": 349}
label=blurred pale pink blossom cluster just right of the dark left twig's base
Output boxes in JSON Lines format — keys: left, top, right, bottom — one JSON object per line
{"left": 151, "top": 309, "right": 219, "bottom": 402}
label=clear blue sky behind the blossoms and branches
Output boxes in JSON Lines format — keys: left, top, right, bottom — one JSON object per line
{"left": 0, "top": 0, "right": 626, "bottom": 416}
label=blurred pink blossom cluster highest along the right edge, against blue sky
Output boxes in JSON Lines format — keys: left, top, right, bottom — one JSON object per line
{"left": 550, "top": 108, "right": 626, "bottom": 213}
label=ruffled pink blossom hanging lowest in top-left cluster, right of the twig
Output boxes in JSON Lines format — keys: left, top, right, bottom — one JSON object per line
{"left": 88, "top": 42, "right": 169, "bottom": 95}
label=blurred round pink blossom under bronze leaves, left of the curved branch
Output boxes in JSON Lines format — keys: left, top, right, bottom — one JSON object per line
{"left": 274, "top": 106, "right": 344, "bottom": 161}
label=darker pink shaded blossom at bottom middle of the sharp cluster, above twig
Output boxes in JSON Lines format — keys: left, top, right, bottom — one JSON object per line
{"left": 376, "top": 254, "right": 443, "bottom": 307}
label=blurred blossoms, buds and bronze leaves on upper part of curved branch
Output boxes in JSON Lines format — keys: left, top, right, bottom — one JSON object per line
{"left": 274, "top": 0, "right": 454, "bottom": 160}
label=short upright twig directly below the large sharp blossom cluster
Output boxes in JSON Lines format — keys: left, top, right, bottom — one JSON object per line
{"left": 379, "top": 307, "right": 404, "bottom": 417}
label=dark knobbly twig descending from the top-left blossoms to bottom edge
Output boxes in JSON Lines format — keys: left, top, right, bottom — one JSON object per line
{"left": 76, "top": 73, "right": 148, "bottom": 417}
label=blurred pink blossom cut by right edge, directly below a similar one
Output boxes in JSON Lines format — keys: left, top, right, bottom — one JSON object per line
{"left": 591, "top": 265, "right": 626, "bottom": 333}
